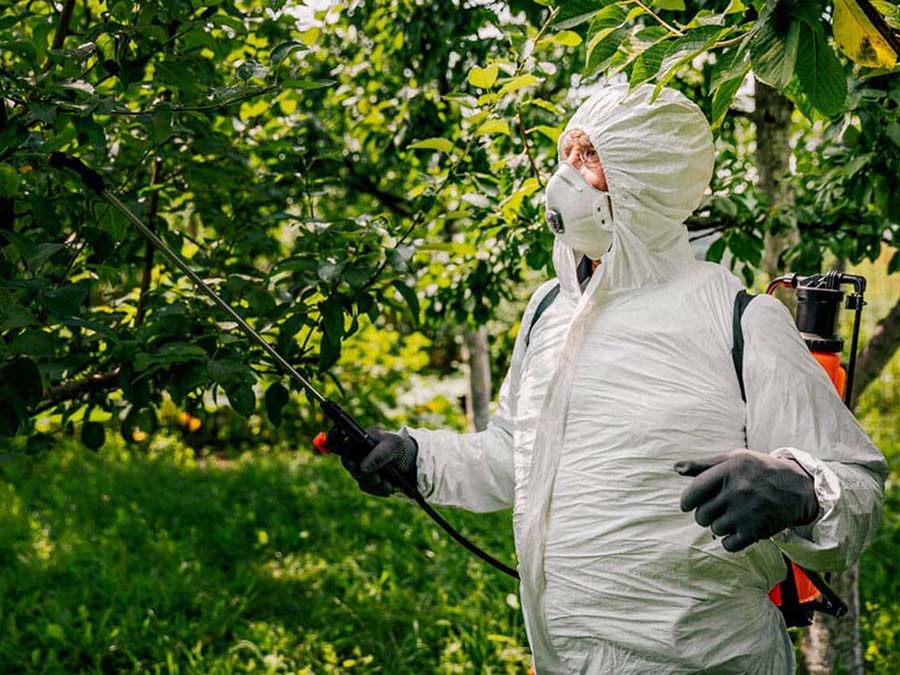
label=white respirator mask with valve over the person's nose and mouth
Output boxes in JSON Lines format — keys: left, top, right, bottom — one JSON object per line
{"left": 546, "top": 162, "right": 613, "bottom": 260}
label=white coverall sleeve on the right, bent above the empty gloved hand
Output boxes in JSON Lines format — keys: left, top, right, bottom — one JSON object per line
{"left": 741, "top": 295, "right": 887, "bottom": 571}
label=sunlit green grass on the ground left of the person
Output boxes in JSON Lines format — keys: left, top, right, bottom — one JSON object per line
{"left": 0, "top": 442, "right": 529, "bottom": 673}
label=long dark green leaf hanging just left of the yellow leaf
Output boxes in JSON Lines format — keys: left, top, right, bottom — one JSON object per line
{"left": 797, "top": 24, "right": 847, "bottom": 117}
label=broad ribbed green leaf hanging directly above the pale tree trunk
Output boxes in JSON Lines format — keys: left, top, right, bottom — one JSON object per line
{"left": 749, "top": 10, "right": 802, "bottom": 91}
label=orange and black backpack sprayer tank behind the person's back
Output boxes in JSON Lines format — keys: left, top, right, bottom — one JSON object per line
{"left": 766, "top": 272, "right": 866, "bottom": 626}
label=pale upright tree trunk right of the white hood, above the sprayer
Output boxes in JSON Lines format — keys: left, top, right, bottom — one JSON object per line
{"left": 753, "top": 80, "right": 799, "bottom": 278}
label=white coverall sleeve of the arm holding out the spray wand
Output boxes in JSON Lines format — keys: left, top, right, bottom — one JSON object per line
{"left": 407, "top": 281, "right": 555, "bottom": 512}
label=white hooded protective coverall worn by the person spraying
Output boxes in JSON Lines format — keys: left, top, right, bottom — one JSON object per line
{"left": 410, "top": 86, "right": 886, "bottom": 675}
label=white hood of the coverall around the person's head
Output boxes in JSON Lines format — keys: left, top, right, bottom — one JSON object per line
{"left": 553, "top": 84, "right": 715, "bottom": 298}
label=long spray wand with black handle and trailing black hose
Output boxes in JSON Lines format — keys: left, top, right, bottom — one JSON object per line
{"left": 49, "top": 152, "right": 519, "bottom": 579}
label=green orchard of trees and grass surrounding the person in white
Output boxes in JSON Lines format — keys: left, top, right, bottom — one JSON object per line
{"left": 0, "top": 0, "right": 900, "bottom": 673}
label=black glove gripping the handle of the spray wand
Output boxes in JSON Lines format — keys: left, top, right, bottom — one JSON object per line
{"left": 337, "top": 427, "right": 419, "bottom": 497}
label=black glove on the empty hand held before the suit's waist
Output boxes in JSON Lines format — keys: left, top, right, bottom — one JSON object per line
{"left": 675, "top": 450, "right": 819, "bottom": 552}
